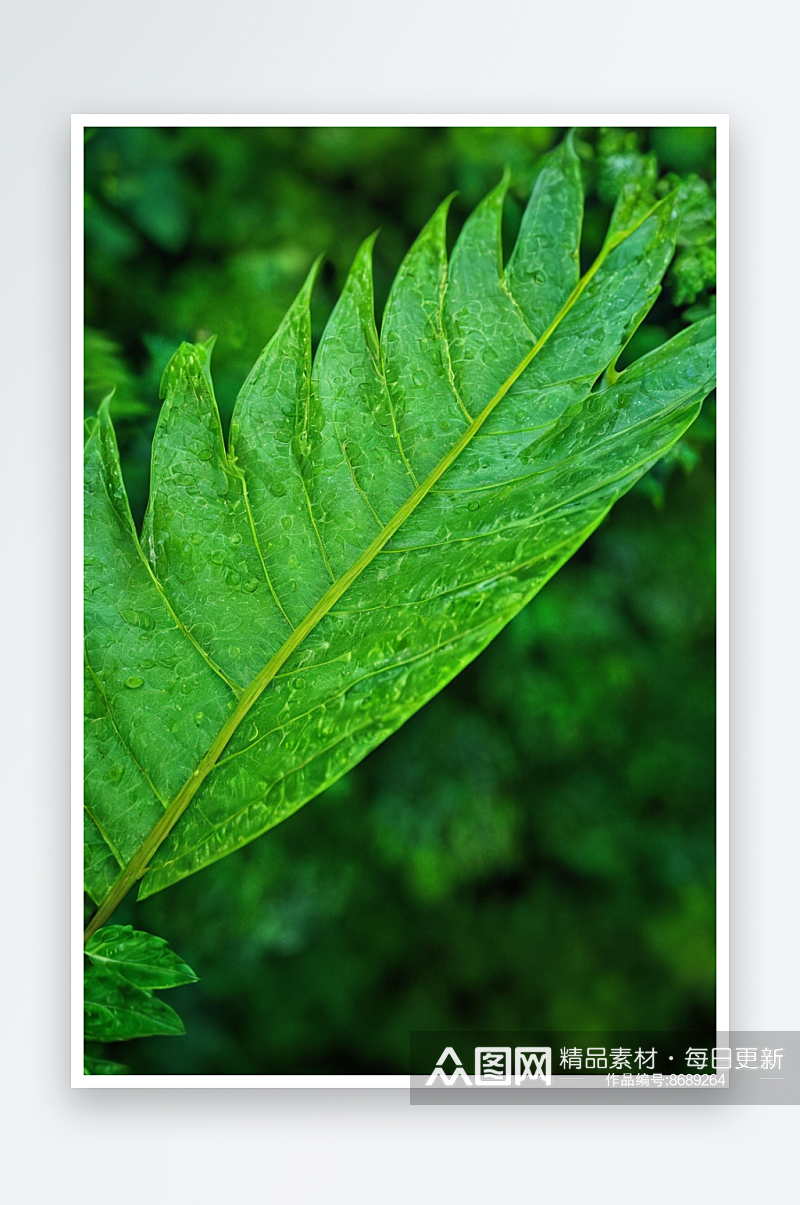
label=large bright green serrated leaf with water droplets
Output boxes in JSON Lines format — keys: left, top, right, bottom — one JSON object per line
{"left": 86, "top": 131, "right": 714, "bottom": 931}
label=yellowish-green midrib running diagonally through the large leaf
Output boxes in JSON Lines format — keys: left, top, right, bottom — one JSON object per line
{"left": 83, "top": 202, "right": 672, "bottom": 944}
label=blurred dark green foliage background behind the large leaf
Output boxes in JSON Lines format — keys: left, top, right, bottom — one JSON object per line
{"left": 86, "top": 128, "right": 714, "bottom": 1074}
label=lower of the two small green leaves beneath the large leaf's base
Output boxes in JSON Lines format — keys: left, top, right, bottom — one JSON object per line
{"left": 83, "top": 964, "right": 186, "bottom": 1042}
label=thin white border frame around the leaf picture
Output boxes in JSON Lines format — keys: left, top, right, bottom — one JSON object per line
{"left": 70, "top": 113, "right": 730, "bottom": 1088}
